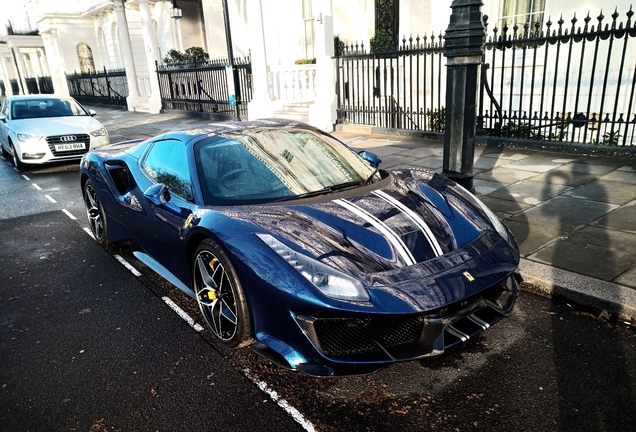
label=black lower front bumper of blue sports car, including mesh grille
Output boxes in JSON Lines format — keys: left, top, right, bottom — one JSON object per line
{"left": 297, "top": 275, "right": 519, "bottom": 376}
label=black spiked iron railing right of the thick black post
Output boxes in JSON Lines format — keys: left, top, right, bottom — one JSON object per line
{"left": 478, "top": 9, "right": 636, "bottom": 145}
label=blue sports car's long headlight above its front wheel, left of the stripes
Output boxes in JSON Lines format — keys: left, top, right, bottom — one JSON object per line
{"left": 256, "top": 234, "right": 370, "bottom": 301}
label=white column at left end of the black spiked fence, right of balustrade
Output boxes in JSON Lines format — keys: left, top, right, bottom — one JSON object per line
{"left": 309, "top": 0, "right": 336, "bottom": 132}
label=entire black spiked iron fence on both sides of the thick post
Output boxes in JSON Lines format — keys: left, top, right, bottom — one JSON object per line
{"left": 336, "top": 9, "right": 636, "bottom": 145}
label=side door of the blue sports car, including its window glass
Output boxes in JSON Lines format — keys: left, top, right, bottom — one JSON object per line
{"left": 134, "top": 139, "right": 196, "bottom": 280}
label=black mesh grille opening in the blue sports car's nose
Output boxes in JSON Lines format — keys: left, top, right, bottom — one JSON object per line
{"left": 314, "top": 316, "right": 424, "bottom": 356}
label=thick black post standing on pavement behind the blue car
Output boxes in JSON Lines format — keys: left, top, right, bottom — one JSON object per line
{"left": 443, "top": 0, "right": 486, "bottom": 192}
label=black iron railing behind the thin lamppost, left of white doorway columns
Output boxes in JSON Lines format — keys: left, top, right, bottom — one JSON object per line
{"left": 157, "top": 57, "right": 253, "bottom": 117}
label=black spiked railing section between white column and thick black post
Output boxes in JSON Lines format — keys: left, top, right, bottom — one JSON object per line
{"left": 336, "top": 35, "right": 446, "bottom": 131}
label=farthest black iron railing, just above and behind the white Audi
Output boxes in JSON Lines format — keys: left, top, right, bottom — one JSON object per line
{"left": 66, "top": 67, "right": 128, "bottom": 106}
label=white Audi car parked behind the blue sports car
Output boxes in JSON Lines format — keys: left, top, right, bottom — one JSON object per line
{"left": 0, "top": 95, "right": 109, "bottom": 171}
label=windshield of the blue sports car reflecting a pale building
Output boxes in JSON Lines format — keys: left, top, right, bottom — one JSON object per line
{"left": 195, "top": 129, "right": 379, "bottom": 205}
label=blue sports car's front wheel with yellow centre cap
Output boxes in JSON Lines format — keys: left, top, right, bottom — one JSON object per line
{"left": 192, "top": 239, "right": 254, "bottom": 348}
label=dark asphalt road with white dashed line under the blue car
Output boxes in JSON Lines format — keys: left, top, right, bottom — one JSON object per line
{"left": 0, "top": 160, "right": 636, "bottom": 432}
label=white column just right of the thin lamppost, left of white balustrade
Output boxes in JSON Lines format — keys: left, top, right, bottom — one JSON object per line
{"left": 246, "top": 0, "right": 274, "bottom": 120}
